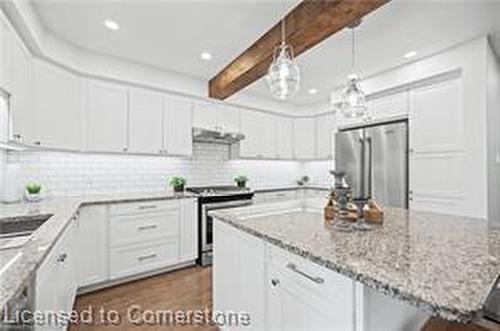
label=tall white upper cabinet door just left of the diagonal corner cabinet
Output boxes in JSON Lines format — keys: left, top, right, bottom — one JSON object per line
{"left": 10, "top": 34, "right": 36, "bottom": 144}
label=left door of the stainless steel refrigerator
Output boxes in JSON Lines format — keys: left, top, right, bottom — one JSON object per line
{"left": 335, "top": 129, "right": 364, "bottom": 196}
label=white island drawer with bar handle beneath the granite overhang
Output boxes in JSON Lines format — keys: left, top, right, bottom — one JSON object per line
{"left": 267, "top": 246, "right": 354, "bottom": 306}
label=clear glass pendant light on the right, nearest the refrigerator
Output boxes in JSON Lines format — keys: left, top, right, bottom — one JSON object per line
{"left": 338, "top": 20, "right": 369, "bottom": 118}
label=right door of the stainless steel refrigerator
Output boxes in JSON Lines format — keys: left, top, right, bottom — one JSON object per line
{"left": 365, "top": 122, "right": 408, "bottom": 208}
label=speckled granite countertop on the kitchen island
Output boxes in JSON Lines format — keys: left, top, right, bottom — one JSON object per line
{"left": 211, "top": 199, "right": 500, "bottom": 323}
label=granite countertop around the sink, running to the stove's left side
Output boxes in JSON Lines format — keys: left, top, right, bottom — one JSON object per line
{"left": 0, "top": 192, "right": 197, "bottom": 308}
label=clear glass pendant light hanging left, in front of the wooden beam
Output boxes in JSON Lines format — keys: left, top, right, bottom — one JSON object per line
{"left": 266, "top": 18, "right": 300, "bottom": 100}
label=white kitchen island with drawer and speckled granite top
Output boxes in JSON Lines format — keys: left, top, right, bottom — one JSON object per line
{"left": 212, "top": 199, "right": 500, "bottom": 331}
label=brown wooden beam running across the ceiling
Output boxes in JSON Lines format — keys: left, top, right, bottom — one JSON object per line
{"left": 208, "top": 0, "right": 389, "bottom": 100}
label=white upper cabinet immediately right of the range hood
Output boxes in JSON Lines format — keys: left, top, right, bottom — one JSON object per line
{"left": 240, "top": 110, "right": 277, "bottom": 159}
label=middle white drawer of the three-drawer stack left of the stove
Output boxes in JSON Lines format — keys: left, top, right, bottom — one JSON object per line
{"left": 109, "top": 208, "right": 180, "bottom": 247}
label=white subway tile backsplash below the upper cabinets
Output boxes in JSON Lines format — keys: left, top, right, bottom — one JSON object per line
{"left": 7, "top": 143, "right": 331, "bottom": 196}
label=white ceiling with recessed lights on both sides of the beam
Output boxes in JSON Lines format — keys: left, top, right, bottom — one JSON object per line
{"left": 35, "top": 0, "right": 500, "bottom": 105}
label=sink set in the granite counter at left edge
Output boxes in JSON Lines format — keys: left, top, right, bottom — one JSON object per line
{"left": 0, "top": 214, "right": 52, "bottom": 250}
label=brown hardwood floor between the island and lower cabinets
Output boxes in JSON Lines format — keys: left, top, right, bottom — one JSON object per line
{"left": 70, "top": 267, "right": 218, "bottom": 331}
